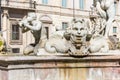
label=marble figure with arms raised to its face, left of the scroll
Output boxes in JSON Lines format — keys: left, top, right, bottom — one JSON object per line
{"left": 19, "top": 12, "right": 42, "bottom": 54}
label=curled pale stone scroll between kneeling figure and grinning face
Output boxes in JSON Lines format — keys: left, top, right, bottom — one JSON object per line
{"left": 44, "top": 35, "right": 70, "bottom": 53}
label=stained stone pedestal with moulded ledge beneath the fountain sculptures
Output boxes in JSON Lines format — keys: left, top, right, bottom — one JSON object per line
{"left": 0, "top": 55, "right": 120, "bottom": 80}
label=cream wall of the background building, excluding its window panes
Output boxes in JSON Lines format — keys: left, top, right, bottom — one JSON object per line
{"left": 1, "top": 0, "right": 120, "bottom": 53}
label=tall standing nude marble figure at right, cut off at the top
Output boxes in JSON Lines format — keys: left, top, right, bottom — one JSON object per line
{"left": 94, "top": 0, "right": 115, "bottom": 38}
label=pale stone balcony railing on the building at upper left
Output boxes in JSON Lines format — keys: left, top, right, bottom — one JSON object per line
{"left": 1, "top": 0, "right": 36, "bottom": 9}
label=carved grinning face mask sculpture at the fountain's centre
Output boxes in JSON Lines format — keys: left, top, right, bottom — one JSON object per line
{"left": 64, "top": 19, "right": 88, "bottom": 55}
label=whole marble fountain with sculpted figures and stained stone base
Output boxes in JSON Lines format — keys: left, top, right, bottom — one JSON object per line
{"left": 0, "top": 0, "right": 120, "bottom": 80}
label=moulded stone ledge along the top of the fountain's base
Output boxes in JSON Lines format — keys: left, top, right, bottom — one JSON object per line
{"left": 0, "top": 54, "right": 120, "bottom": 70}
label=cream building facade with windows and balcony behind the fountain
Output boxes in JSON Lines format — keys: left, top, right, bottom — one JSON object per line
{"left": 0, "top": 0, "right": 120, "bottom": 53}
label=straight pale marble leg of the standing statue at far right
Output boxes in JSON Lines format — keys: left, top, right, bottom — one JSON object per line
{"left": 105, "top": 4, "right": 115, "bottom": 38}
